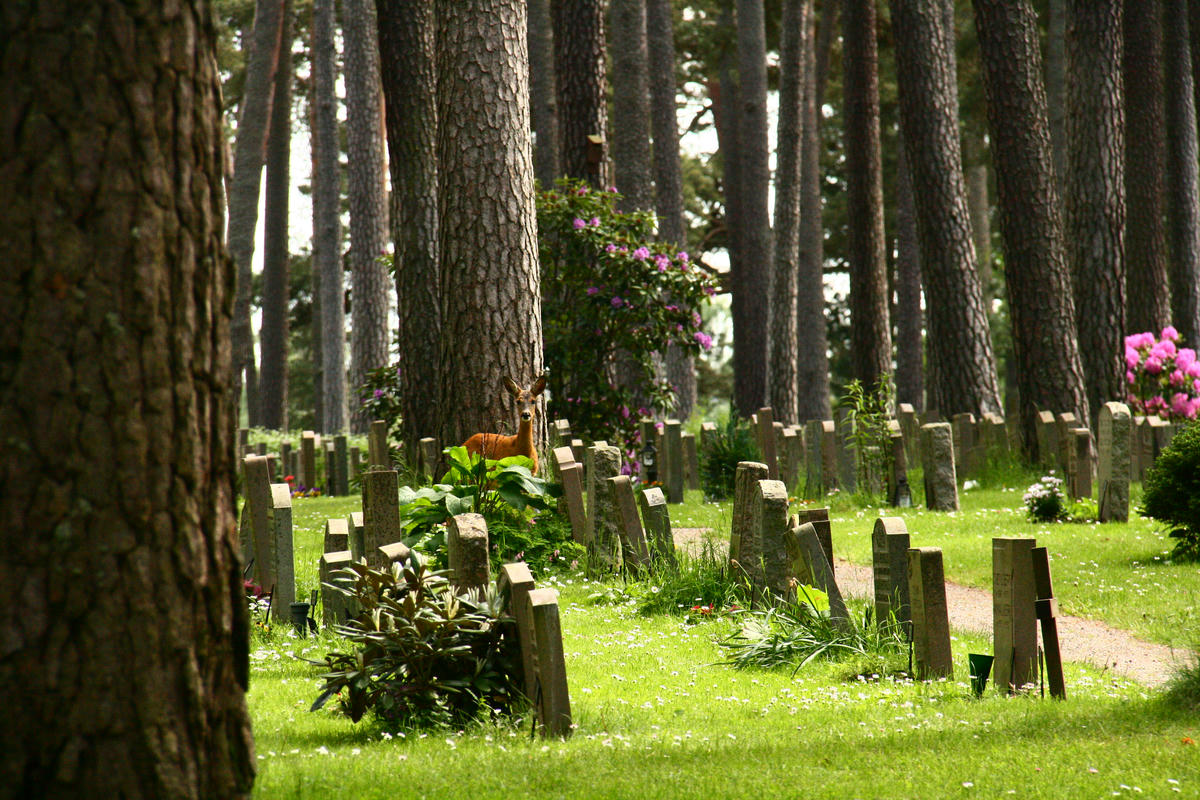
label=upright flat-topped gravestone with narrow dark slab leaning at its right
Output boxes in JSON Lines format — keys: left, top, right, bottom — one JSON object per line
{"left": 991, "top": 537, "right": 1038, "bottom": 692}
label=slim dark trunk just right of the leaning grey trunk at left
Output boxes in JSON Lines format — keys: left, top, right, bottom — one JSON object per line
{"left": 258, "top": 0, "right": 293, "bottom": 431}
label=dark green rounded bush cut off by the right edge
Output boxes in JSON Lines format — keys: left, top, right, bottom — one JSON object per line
{"left": 1141, "top": 423, "right": 1200, "bottom": 561}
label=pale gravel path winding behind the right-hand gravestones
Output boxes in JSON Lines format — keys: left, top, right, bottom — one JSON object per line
{"left": 672, "top": 528, "right": 1184, "bottom": 686}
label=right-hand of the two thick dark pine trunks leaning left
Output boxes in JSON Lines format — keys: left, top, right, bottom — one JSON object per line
{"left": 973, "top": 0, "right": 1086, "bottom": 458}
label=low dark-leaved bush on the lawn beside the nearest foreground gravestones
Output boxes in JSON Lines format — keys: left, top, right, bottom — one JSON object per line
{"left": 311, "top": 553, "right": 524, "bottom": 728}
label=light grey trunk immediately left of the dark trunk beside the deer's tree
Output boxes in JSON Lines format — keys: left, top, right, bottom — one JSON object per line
{"left": 342, "top": 0, "right": 391, "bottom": 433}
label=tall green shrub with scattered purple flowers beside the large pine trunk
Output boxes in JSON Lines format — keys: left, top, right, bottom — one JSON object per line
{"left": 538, "top": 181, "right": 716, "bottom": 470}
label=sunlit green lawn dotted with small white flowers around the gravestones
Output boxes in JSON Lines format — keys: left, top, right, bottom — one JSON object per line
{"left": 247, "top": 486, "right": 1200, "bottom": 798}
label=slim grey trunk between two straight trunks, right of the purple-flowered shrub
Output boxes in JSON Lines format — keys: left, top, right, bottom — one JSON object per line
{"left": 769, "top": 0, "right": 811, "bottom": 425}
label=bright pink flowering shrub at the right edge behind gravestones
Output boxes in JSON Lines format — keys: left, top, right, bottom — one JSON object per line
{"left": 1124, "top": 325, "right": 1200, "bottom": 420}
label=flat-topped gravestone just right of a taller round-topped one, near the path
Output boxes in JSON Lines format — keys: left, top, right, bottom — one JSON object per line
{"left": 906, "top": 547, "right": 954, "bottom": 680}
